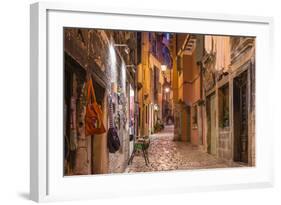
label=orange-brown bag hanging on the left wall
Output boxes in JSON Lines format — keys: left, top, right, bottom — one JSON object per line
{"left": 85, "top": 79, "right": 106, "bottom": 136}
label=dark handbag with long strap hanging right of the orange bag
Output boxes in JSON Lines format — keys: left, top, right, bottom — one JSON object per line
{"left": 107, "top": 97, "right": 120, "bottom": 153}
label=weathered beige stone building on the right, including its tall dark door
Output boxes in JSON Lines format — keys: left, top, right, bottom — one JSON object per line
{"left": 198, "top": 36, "right": 255, "bottom": 165}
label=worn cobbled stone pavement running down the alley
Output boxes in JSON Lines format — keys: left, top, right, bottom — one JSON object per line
{"left": 125, "top": 126, "right": 237, "bottom": 172}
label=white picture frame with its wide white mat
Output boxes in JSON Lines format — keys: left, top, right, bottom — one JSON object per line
{"left": 30, "top": 2, "right": 274, "bottom": 202}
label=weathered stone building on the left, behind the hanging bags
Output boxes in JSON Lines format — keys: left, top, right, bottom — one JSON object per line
{"left": 64, "top": 28, "right": 137, "bottom": 175}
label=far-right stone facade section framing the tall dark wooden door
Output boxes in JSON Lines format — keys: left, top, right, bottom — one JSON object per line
{"left": 230, "top": 37, "right": 255, "bottom": 166}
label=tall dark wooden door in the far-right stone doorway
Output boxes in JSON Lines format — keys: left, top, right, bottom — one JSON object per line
{"left": 233, "top": 71, "right": 248, "bottom": 163}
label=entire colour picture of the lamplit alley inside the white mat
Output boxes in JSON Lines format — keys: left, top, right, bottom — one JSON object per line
{"left": 63, "top": 27, "right": 256, "bottom": 176}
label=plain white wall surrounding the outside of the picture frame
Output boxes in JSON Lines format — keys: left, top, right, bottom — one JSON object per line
{"left": 0, "top": 0, "right": 281, "bottom": 205}
